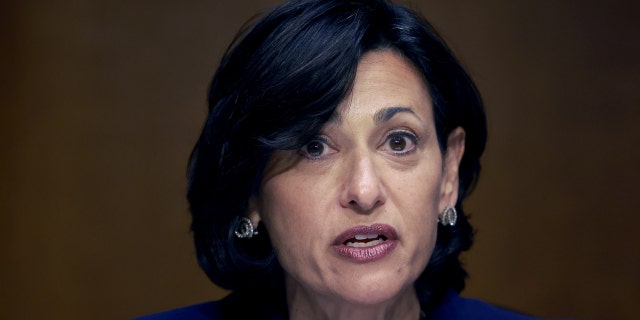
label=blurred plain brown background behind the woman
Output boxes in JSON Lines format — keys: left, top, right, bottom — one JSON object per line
{"left": 0, "top": 0, "right": 640, "bottom": 319}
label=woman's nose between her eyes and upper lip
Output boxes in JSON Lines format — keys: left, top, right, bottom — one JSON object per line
{"left": 340, "top": 155, "right": 386, "bottom": 213}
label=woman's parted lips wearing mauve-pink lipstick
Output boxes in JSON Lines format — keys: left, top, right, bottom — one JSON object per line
{"left": 332, "top": 224, "right": 398, "bottom": 263}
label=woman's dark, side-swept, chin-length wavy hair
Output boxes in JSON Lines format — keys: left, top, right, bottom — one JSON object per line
{"left": 188, "top": 0, "right": 487, "bottom": 311}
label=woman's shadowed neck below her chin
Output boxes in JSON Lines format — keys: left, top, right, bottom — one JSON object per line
{"left": 286, "top": 278, "right": 420, "bottom": 320}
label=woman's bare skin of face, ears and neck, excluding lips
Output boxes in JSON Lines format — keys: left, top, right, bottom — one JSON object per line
{"left": 248, "top": 50, "right": 465, "bottom": 319}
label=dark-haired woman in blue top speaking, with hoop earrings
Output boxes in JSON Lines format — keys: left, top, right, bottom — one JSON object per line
{"left": 139, "top": 0, "right": 536, "bottom": 319}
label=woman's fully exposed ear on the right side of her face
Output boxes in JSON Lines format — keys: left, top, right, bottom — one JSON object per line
{"left": 439, "top": 127, "right": 465, "bottom": 212}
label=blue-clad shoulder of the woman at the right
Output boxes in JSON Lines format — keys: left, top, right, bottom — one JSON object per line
{"left": 432, "top": 291, "right": 536, "bottom": 320}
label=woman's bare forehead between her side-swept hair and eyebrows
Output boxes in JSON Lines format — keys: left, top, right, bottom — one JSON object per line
{"left": 334, "top": 50, "right": 431, "bottom": 122}
